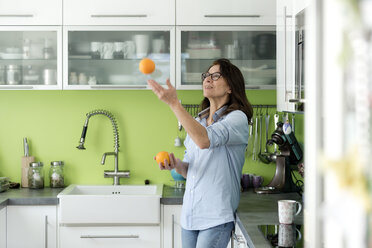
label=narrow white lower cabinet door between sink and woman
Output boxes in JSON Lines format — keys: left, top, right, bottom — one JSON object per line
{"left": 163, "top": 205, "right": 182, "bottom": 248}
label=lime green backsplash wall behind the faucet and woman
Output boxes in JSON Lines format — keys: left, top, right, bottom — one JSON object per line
{"left": 0, "top": 90, "right": 303, "bottom": 186}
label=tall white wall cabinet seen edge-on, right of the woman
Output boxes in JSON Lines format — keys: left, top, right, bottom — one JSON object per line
{"left": 276, "top": 0, "right": 308, "bottom": 112}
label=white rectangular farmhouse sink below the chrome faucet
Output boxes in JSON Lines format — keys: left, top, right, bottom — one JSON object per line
{"left": 58, "top": 184, "right": 163, "bottom": 225}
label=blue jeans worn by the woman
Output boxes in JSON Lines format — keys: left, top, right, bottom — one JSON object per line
{"left": 182, "top": 222, "right": 234, "bottom": 248}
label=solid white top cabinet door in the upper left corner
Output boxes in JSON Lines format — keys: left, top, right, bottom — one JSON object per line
{"left": 0, "top": 0, "right": 62, "bottom": 25}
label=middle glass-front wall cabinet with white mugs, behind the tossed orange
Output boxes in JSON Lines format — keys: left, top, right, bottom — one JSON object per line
{"left": 63, "top": 26, "right": 175, "bottom": 89}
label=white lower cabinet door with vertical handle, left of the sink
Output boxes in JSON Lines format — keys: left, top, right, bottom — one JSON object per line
{"left": 7, "top": 206, "right": 57, "bottom": 248}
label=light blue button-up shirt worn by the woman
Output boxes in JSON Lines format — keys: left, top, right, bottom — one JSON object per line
{"left": 181, "top": 106, "right": 249, "bottom": 230}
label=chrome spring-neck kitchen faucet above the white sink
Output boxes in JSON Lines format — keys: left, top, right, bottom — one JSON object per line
{"left": 76, "top": 110, "right": 130, "bottom": 185}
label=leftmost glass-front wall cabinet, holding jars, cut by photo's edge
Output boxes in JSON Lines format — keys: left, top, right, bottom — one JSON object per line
{"left": 0, "top": 26, "right": 62, "bottom": 89}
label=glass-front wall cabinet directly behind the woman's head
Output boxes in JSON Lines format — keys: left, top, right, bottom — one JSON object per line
{"left": 176, "top": 26, "right": 276, "bottom": 89}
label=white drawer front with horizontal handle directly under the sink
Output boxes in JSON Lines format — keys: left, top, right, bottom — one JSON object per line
{"left": 60, "top": 226, "right": 160, "bottom": 248}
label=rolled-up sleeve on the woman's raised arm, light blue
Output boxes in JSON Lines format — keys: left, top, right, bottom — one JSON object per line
{"left": 206, "top": 110, "right": 248, "bottom": 148}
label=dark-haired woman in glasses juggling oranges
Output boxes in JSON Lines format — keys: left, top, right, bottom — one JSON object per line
{"left": 148, "top": 59, "right": 253, "bottom": 248}
